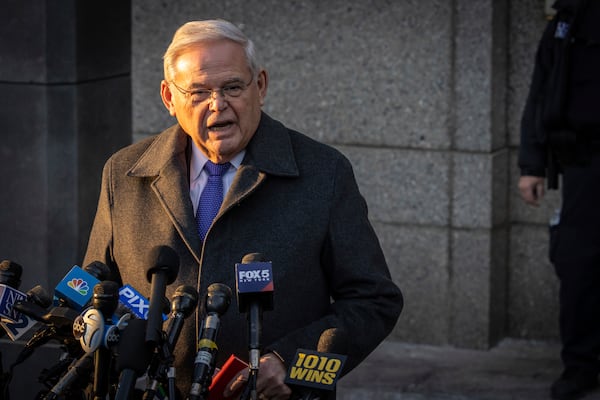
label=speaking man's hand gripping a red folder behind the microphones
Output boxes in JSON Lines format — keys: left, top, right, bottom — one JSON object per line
{"left": 224, "top": 353, "right": 292, "bottom": 400}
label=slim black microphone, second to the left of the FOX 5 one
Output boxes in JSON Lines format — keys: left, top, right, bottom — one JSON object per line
{"left": 144, "top": 285, "right": 198, "bottom": 400}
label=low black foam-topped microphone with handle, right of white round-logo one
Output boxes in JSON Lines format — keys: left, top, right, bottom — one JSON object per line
{"left": 115, "top": 319, "right": 150, "bottom": 400}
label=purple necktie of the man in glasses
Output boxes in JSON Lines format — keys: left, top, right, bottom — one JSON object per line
{"left": 196, "top": 161, "right": 231, "bottom": 241}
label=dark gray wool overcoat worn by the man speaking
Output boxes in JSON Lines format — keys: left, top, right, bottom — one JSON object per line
{"left": 84, "top": 113, "right": 403, "bottom": 393}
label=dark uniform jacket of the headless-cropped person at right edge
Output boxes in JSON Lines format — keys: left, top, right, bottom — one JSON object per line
{"left": 519, "top": 0, "right": 600, "bottom": 176}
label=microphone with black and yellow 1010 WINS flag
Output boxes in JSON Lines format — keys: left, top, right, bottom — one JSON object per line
{"left": 285, "top": 328, "right": 348, "bottom": 400}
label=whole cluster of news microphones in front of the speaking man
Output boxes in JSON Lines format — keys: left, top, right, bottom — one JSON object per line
{"left": 0, "top": 246, "right": 347, "bottom": 400}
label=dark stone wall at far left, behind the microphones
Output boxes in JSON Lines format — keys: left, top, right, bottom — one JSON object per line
{"left": 0, "top": 0, "right": 132, "bottom": 399}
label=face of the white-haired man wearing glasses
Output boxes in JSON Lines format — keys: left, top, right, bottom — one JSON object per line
{"left": 161, "top": 40, "right": 267, "bottom": 163}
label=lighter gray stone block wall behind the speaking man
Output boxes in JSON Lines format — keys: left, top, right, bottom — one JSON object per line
{"left": 133, "top": 0, "right": 556, "bottom": 348}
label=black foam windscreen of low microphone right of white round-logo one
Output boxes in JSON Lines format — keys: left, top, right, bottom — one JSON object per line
{"left": 116, "top": 319, "right": 151, "bottom": 376}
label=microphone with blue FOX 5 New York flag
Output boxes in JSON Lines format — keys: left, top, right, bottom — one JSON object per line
{"left": 235, "top": 253, "right": 274, "bottom": 399}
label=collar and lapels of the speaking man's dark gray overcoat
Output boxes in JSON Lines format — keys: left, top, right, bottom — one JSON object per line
{"left": 127, "top": 113, "right": 299, "bottom": 262}
